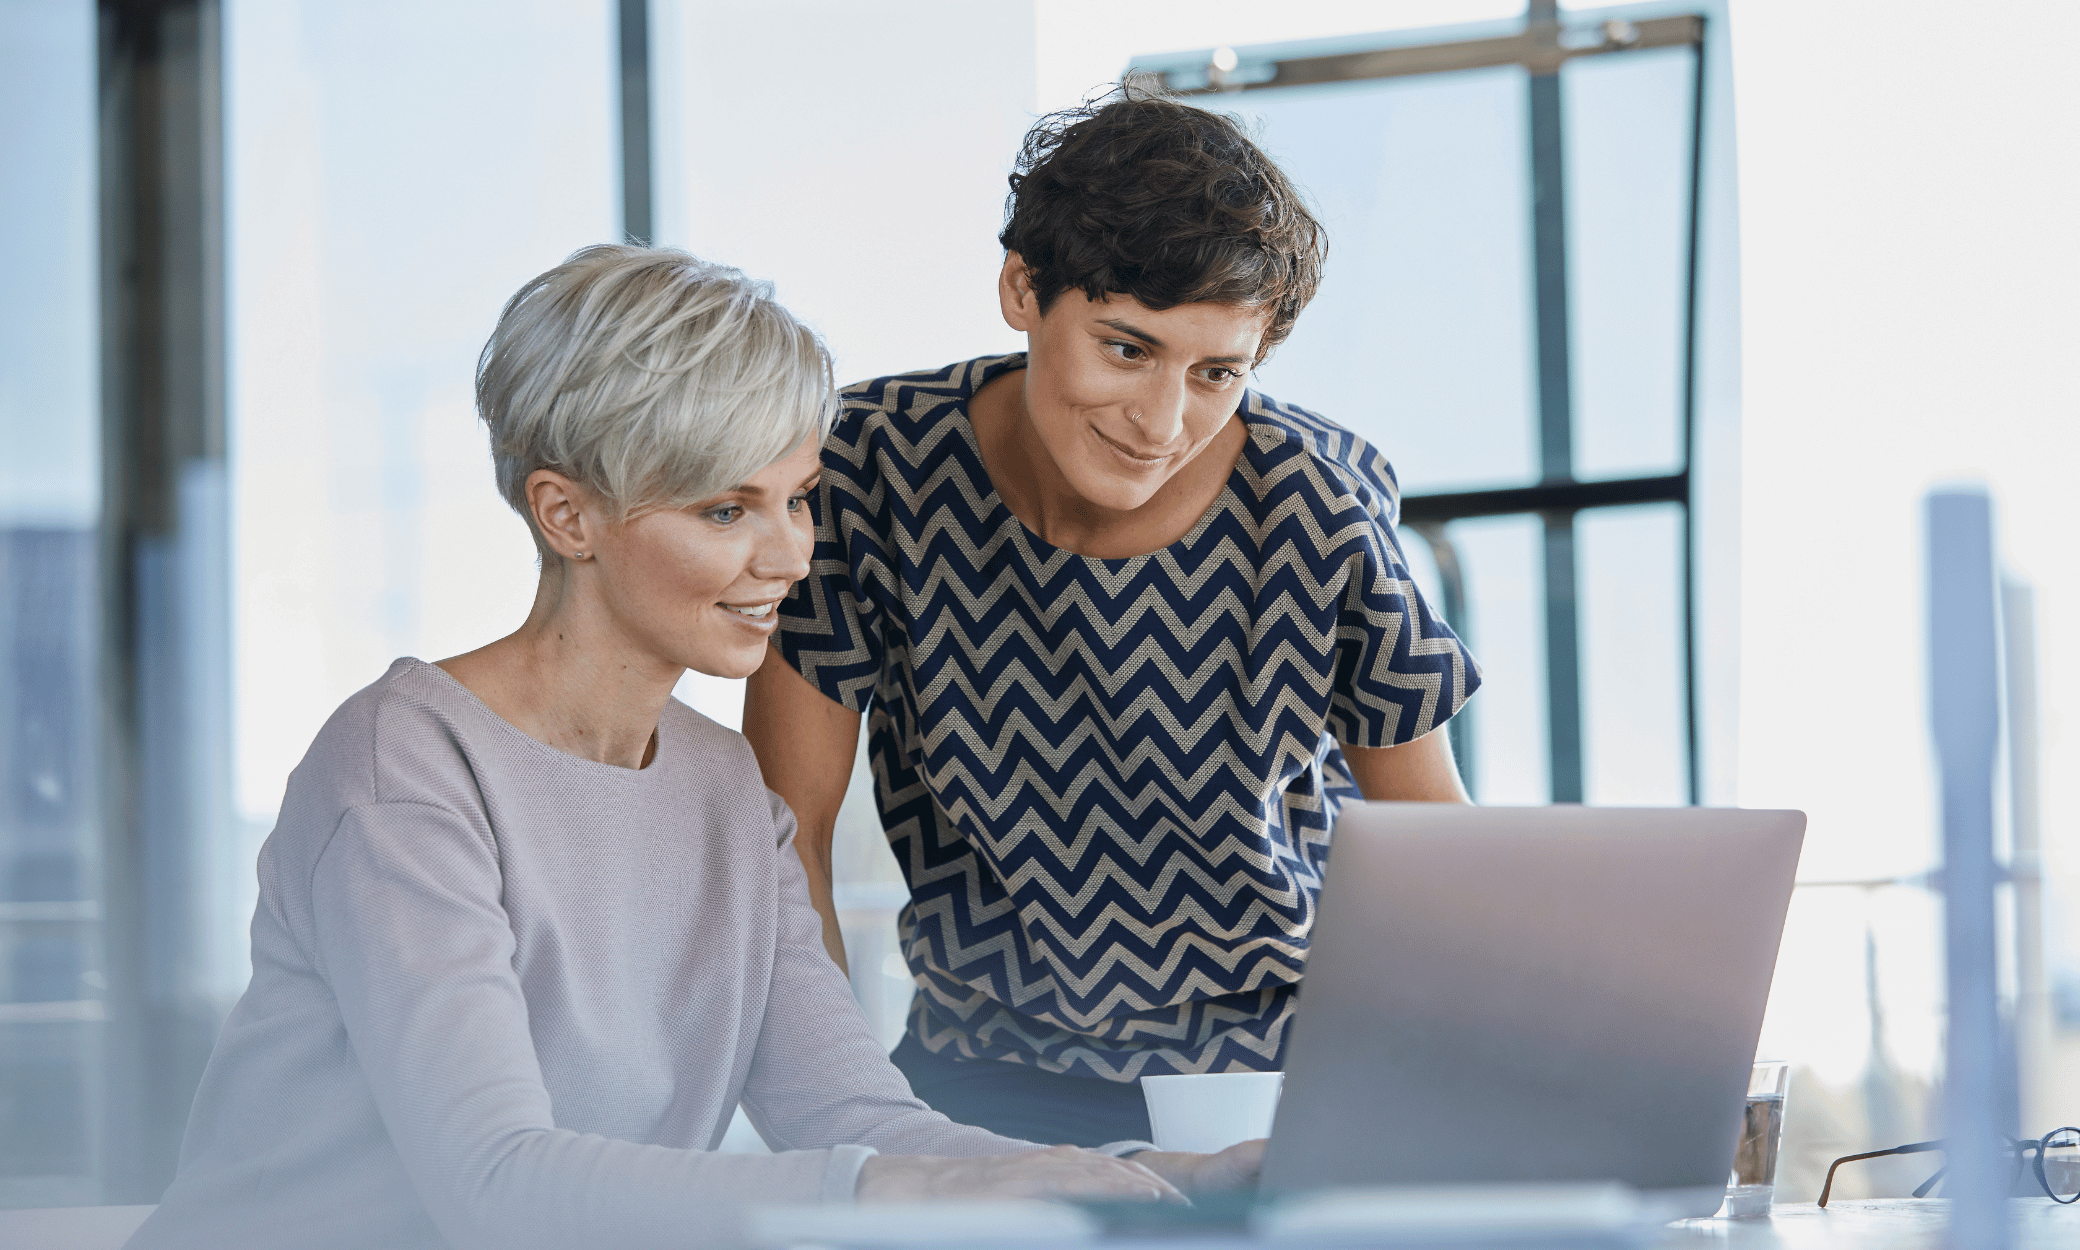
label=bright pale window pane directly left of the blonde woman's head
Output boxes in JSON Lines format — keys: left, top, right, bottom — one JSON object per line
{"left": 225, "top": 0, "right": 620, "bottom": 819}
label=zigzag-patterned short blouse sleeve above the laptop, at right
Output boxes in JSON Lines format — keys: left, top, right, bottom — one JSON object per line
{"left": 1325, "top": 424, "right": 1481, "bottom": 747}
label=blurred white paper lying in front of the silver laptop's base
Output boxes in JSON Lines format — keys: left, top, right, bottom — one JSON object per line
{"left": 1250, "top": 1183, "right": 1645, "bottom": 1242}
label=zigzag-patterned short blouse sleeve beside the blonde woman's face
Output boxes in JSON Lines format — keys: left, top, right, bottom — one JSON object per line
{"left": 772, "top": 403, "right": 888, "bottom": 713}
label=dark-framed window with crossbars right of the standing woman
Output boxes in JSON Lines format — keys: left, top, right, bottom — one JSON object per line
{"left": 1134, "top": 4, "right": 1733, "bottom": 803}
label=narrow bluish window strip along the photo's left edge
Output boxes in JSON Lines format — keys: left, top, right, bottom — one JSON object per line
{"left": 0, "top": 0, "right": 106, "bottom": 1206}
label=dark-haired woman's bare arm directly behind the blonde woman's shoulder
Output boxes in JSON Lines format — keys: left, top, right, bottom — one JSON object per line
{"left": 745, "top": 651, "right": 859, "bottom": 969}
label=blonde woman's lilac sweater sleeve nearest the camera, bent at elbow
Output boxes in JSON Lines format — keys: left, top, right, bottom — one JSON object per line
{"left": 312, "top": 803, "right": 865, "bottom": 1250}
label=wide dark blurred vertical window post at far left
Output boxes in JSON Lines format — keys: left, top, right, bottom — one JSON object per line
{"left": 98, "top": 0, "right": 231, "bottom": 1204}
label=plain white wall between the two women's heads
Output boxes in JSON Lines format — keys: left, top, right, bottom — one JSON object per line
{"left": 653, "top": 0, "right": 1034, "bottom": 724}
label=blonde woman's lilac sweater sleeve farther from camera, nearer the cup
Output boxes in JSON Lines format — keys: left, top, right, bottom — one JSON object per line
{"left": 743, "top": 795, "right": 1040, "bottom": 1173}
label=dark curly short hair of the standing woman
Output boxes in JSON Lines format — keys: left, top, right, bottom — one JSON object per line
{"left": 998, "top": 87, "right": 1327, "bottom": 360}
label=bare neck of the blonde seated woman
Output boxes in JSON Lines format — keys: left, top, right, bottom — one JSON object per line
{"left": 439, "top": 568, "right": 684, "bottom": 767}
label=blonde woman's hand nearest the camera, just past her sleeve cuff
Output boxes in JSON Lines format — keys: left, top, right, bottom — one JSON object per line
{"left": 855, "top": 1146, "right": 1189, "bottom": 1202}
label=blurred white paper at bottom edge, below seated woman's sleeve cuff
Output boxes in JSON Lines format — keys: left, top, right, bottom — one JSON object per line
{"left": 747, "top": 1200, "right": 1098, "bottom": 1246}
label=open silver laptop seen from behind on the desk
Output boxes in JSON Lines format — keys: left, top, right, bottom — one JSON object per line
{"left": 1265, "top": 803, "right": 1805, "bottom": 1219}
